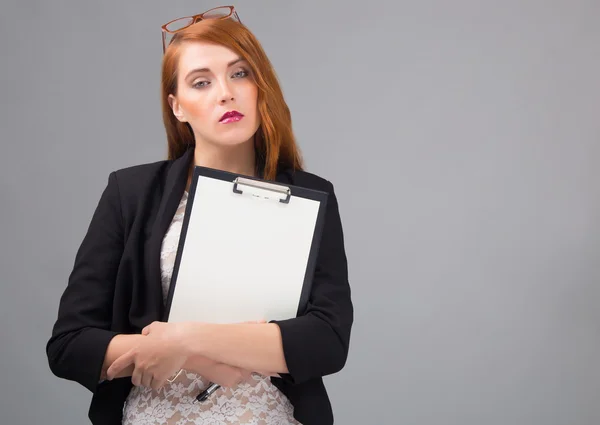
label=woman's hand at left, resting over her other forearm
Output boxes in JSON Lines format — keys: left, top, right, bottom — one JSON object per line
{"left": 106, "top": 322, "right": 189, "bottom": 389}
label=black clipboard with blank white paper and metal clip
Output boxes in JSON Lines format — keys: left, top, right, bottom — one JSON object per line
{"left": 165, "top": 166, "right": 328, "bottom": 323}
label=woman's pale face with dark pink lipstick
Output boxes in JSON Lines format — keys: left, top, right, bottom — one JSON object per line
{"left": 169, "top": 42, "right": 260, "bottom": 146}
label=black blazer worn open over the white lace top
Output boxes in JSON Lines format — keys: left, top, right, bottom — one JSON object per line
{"left": 46, "top": 148, "right": 353, "bottom": 425}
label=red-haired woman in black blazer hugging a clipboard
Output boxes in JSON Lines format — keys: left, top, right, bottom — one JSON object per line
{"left": 47, "top": 7, "right": 353, "bottom": 425}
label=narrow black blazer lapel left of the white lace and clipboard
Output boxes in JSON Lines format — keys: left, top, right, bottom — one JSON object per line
{"left": 146, "top": 147, "right": 194, "bottom": 321}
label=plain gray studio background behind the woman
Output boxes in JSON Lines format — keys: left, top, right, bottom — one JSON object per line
{"left": 0, "top": 0, "right": 600, "bottom": 425}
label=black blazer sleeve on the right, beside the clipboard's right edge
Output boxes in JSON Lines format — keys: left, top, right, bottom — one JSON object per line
{"left": 273, "top": 182, "right": 353, "bottom": 384}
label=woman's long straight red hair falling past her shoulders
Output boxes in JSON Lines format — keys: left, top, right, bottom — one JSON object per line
{"left": 161, "top": 19, "right": 303, "bottom": 180}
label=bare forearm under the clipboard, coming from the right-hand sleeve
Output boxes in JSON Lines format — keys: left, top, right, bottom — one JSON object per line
{"left": 186, "top": 323, "right": 288, "bottom": 373}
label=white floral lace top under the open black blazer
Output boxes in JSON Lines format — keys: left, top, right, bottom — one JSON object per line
{"left": 123, "top": 191, "right": 300, "bottom": 425}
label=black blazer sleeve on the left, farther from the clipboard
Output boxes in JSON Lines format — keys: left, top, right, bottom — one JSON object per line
{"left": 46, "top": 172, "right": 124, "bottom": 392}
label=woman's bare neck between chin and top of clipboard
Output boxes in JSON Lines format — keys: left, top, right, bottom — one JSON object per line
{"left": 194, "top": 139, "right": 256, "bottom": 176}
